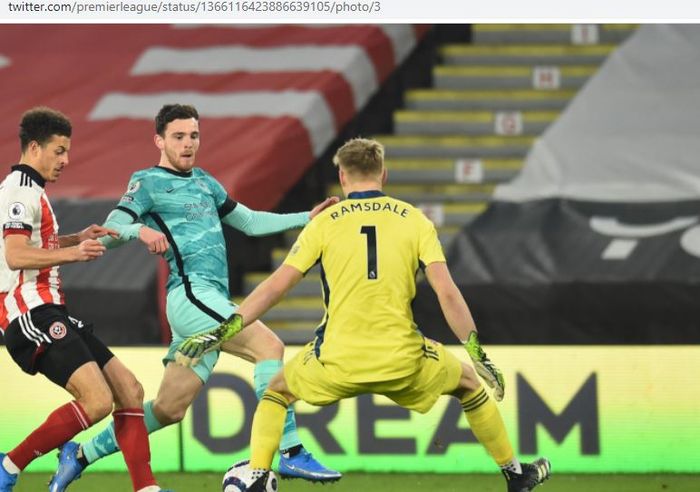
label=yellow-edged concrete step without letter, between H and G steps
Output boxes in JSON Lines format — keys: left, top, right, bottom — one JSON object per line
{"left": 405, "top": 89, "right": 576, "bottom": 111}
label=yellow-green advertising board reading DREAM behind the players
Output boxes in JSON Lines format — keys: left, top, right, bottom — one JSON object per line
{"left": 0, "top": 346, "right": 700, "bottom": 473}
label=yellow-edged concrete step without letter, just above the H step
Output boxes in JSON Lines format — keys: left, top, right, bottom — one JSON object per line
{"left": 439, "top": 44, "right": 617, "bottom": 65}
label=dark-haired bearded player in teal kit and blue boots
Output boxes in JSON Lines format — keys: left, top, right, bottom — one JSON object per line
{"left": 49, "top": 104, "right": 341, "bottom": 492}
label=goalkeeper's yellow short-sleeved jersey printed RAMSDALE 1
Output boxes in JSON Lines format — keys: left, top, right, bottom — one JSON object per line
{"left": 285, "top": 191, "right": 445, "bottom": 382}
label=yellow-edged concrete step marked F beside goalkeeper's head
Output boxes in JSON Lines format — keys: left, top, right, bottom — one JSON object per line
{"left": 386, "top": 158, "right": 523, "bottom": 184}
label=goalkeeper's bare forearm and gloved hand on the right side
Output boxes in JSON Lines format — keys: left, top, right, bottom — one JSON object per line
{"left": 425, "top": 262, "right": 505, "bottom": 401}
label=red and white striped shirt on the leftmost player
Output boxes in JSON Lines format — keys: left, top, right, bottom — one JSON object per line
{"left": 0, "top": 164, "right": 64, "bottom": 332}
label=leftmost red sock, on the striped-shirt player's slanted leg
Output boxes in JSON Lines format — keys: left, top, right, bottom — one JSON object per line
{"left": 7, "top": 401, "right": 92, "bottom": 470}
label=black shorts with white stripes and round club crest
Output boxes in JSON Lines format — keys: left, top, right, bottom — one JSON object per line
{"left": 5, "top": 304, "right": 114, "bottom": 388}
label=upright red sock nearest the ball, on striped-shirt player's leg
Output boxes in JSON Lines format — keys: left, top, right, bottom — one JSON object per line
{"left": 112, "top": 408, "right": 156, "bottom": 490}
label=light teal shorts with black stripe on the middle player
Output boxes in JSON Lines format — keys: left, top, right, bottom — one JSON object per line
{"left": 163, "top": 285, "right": 238, "bottom": 384}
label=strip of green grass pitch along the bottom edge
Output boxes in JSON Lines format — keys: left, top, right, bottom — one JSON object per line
{"left": 13, "top": 472, "right": 700, "bottom": 492}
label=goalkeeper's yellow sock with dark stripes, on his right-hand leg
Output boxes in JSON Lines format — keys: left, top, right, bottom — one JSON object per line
{"left": 460, "top": 386, "right": 514, "bottom": 466}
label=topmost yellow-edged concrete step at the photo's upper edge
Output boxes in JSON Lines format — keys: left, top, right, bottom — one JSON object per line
{"left": 472, "top": 24, "right": 638, "bottom": 44}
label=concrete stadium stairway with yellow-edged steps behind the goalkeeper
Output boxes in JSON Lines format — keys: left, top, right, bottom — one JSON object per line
{"left": 244, "top": 24, "right": 636, "bottom": 343}
